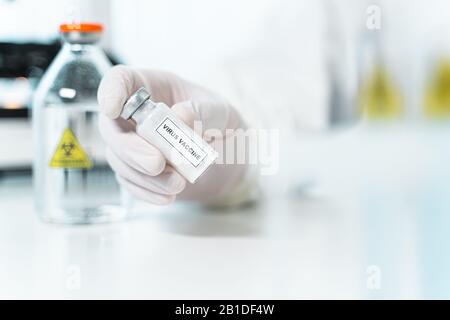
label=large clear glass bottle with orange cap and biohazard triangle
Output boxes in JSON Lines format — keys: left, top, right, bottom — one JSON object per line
{"left": 33, "top": 24, "right": 127, "bottom": 223}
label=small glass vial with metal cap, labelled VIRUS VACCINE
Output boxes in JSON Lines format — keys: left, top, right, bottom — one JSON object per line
{"left": 120, "top": 88, "right": 218, "bottom": 183}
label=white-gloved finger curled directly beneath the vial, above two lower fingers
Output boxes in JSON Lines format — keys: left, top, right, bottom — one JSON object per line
{"left": 99, "top": 115, "right": 166, "bottom": 176}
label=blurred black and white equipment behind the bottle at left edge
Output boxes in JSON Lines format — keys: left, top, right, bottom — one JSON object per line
{"left": 0, "top": 41, "right": 60, "bottom": 170}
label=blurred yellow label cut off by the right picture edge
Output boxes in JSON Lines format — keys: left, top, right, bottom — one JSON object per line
{"left": 424, "top": 59, "right": 450, "bottom": 118}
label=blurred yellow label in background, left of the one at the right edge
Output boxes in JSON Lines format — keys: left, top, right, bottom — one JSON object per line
{"left": 359, "top": 65, "right": 402, "bottom": 119}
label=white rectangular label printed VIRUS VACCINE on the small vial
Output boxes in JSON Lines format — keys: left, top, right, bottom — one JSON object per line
{"left": 156, "top": 117, "right": 207, "bottom": 167}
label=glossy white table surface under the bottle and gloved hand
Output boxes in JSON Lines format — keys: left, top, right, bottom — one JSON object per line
{"left": 0, "top": 126, "right": 450, "bottom": 299}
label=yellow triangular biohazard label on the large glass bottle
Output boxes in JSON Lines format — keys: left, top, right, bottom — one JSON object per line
{"left": 49, "top": 128, "right": 92, "bottom": 169}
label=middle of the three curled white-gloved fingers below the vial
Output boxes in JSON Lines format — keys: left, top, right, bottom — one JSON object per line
{"left": 106, "top": 149, "right": 186, "bottom": 195}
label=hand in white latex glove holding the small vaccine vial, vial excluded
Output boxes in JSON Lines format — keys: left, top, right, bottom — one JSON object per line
{"left": 98, "top": 66, "right": 253, "bottom": 204}
